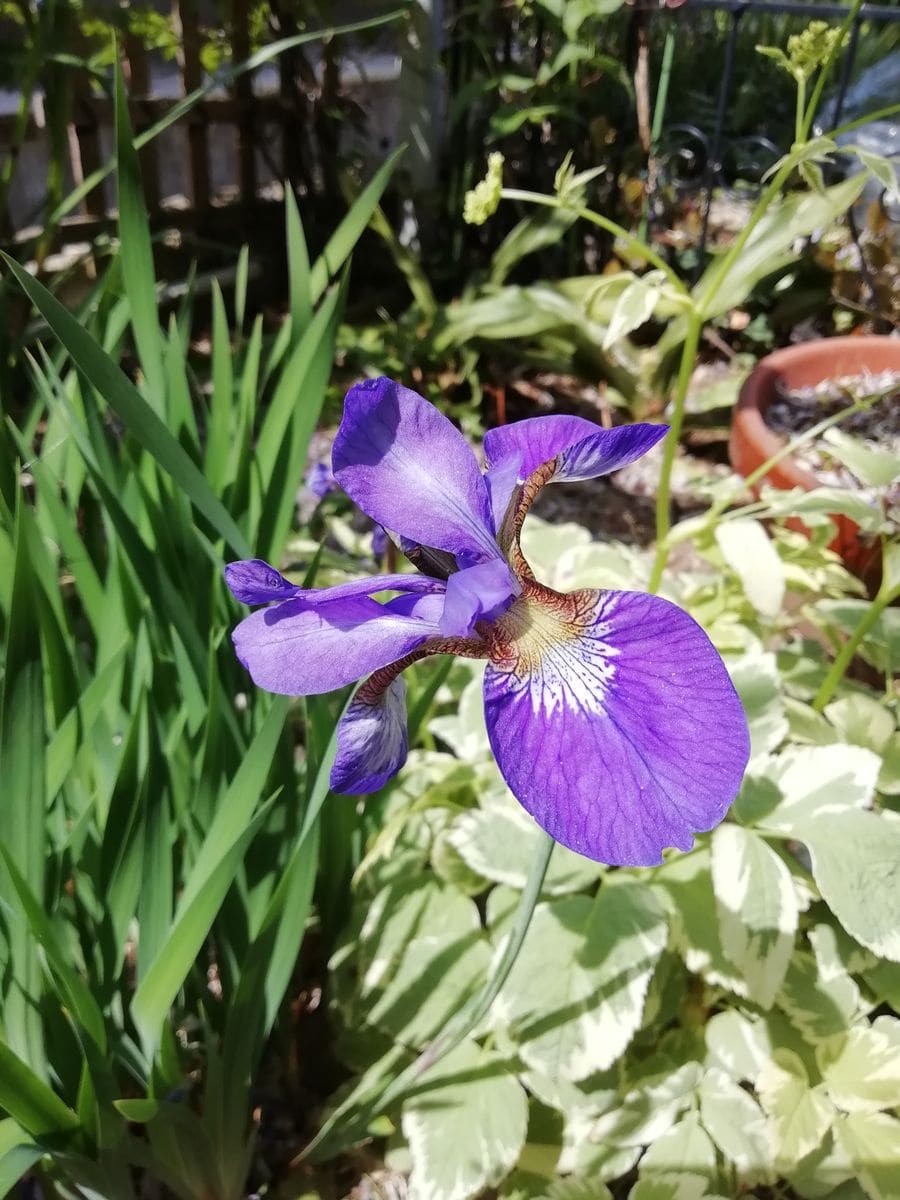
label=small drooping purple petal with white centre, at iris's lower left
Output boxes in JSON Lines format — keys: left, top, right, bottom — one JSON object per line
{"left": 331, "top": 677, "right": 409, "bottom": 793}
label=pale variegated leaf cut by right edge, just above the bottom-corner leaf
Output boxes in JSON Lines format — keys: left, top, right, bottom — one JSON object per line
{"left": 816, "top": 1015, "right": 900, "bottom": 1112}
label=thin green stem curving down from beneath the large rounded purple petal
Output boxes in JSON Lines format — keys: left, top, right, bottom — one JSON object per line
{"left": 303, "top": 832, "right": 556, "bottom": 1166}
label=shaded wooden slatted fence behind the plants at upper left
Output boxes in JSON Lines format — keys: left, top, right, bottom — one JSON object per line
{"left": 0, "top": 0, "right": 393, "bottom": 242}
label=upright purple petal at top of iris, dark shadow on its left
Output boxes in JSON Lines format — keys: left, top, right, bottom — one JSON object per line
{"left": 331, "top": 378, "right": 499, "bottom": 560}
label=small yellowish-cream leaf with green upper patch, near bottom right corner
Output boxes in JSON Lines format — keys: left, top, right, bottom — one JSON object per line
{"left": 756, "top": 1050, "right": 835, "bottom": 1166}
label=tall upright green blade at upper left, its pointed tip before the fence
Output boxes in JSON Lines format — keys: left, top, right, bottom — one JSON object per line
{"left": 114, "top": 62, "right": 166, "bottom": 416}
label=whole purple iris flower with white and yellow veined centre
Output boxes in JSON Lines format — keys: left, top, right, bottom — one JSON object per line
{"left": 226, "top": 379, "right": 749, "bottom": 866}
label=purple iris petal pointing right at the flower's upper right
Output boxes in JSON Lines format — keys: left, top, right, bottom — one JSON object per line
{"left": 485, "top": 415, "right": 668, "bottom": 482}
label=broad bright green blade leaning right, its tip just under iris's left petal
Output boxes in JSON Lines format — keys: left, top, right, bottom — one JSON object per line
{"left": 131, "top": 696, "right": 289, "bottom": 1045}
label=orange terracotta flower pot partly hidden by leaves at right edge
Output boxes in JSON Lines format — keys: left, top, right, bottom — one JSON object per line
{"left": 728, "top": 337, "right": 900, "bottom": 583}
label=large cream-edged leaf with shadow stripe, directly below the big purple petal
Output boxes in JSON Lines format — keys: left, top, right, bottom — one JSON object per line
{"left": 496, "top": 883, "right": 668, "bottom": 1080}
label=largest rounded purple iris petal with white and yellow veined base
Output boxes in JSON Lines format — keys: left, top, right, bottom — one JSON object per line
{"left": 485, "top": 584, "right": 749, "bottom": 866}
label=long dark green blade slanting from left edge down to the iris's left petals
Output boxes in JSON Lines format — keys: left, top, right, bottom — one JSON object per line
{"left": 0, "top": 258, "right": 252, "bottom": 558}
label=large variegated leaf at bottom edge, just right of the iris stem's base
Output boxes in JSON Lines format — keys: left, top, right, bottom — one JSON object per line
{"left": 403, "top": 1042, "right": 528, "bottom": 1200}
